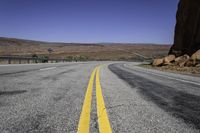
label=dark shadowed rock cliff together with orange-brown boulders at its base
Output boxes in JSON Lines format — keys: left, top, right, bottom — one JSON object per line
{"left": 152, "top": 0, "right": 200, "bottom": 67}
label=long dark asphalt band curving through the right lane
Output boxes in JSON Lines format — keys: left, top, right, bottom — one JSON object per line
{"left": 108, "top": 64, "right": 200, "bottom": 129}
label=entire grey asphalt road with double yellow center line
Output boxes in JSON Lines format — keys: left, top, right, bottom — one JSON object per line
{"left": 0, "top": 62, "right": 200, "bottom": 133}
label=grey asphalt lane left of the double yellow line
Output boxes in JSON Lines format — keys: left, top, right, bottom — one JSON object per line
{"left": 0, "top": 63, "right": 98, "bottom": 133}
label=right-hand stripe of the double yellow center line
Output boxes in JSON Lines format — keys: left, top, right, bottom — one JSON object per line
{"left": 96, "top": 67, "right": 112, "bottom": 133}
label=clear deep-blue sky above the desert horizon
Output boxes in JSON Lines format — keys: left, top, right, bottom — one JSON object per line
{"left": 0, "top": 0, "right": 179, "bottom": 44}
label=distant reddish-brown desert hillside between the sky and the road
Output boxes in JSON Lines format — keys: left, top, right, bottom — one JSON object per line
{"left": 0, "top": 37, "right": 171, "bottom": 60}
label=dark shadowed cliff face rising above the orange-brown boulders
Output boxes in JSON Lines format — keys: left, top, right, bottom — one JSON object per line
{"left": 169, "top": 0, "right": 200, "bottom": 56}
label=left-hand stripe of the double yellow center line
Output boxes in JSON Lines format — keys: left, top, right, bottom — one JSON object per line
{"left": 77, "top": 68, "right": 97, "bottom": 133}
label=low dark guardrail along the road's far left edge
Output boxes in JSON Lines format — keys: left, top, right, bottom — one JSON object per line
{"left": 0, "top": 56, "right": 66, "bottom": 64}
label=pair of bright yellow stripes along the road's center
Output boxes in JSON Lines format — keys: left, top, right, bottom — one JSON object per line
{"left": 78, "top": 66, "right": 112, "bottom": 133}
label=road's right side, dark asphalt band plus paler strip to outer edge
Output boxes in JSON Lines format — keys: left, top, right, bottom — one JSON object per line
{"left": 109, "top": 63, "right": 200, "bottom": 132}
